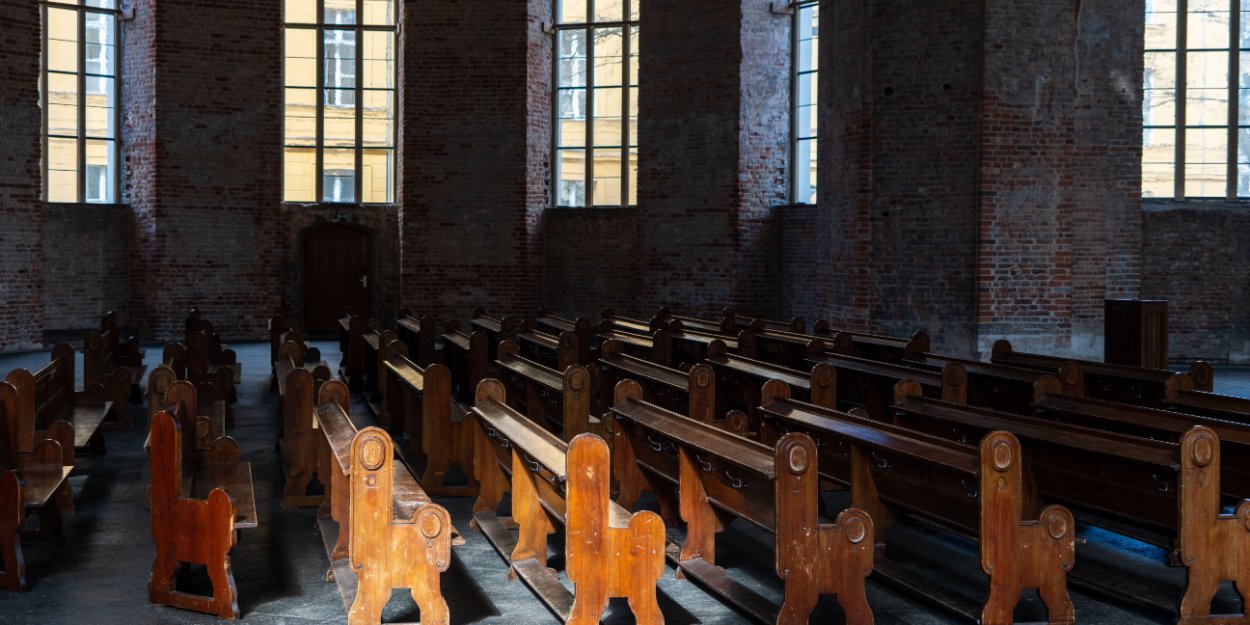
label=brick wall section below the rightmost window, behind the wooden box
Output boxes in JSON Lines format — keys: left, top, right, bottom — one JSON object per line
{"left": 1141, "top": 201, "right": 1250, "bottom": 363}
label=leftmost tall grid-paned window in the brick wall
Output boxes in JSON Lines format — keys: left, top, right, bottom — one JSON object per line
{"left": 41, "top": 0, "right": 119, "bottom": 203}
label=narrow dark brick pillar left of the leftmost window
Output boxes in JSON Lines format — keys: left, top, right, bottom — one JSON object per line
{"left": 0, "top": 0, "right": 44, "bottom": 350}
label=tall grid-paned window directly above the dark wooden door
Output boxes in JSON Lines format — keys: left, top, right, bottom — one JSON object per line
{"left": 283, "top": 0, "right": 396, "bottom": 204}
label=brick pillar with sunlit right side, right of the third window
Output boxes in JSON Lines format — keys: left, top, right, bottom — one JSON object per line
{"left": 638, "top": 0, "right": 790, "bottom": 316}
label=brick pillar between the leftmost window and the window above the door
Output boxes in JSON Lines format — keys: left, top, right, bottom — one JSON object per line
{"left": 124, "top": 0, "right": 284, "bottom": 339}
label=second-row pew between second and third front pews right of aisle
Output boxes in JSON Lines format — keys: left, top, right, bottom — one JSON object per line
{"left": 495, "top": 341, "right": 608, "bottom": 443}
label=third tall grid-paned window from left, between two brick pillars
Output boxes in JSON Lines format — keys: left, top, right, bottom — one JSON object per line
{"left": 554, "top": 0, "right": 639, "bottom": 206}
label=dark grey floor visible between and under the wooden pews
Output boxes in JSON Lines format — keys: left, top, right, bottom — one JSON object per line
{"left": 0, "top": 344, "right": 1250, "bottom": 625}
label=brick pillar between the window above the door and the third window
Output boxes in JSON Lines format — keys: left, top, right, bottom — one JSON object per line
{"left": 400, "top": 0, "right": 551, "bottom": 318}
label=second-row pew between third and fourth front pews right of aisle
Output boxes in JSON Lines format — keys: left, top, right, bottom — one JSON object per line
{"left": 599, "top": 341, "right": 750, "bottom": 436}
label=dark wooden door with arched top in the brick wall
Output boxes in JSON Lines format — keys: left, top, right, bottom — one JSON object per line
{"left": 304, "top": 224, "right": 373, "bottom": 333}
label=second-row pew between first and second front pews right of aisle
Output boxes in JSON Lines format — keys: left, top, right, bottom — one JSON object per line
{"left": 384, "top": 340, "right": 478, "bottom": 496}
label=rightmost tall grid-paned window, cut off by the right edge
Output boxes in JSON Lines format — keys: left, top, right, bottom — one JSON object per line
{"left": 1141, "top": 0, "right": 1250, "bottom": 200}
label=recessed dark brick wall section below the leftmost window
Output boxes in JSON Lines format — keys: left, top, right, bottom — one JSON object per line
{"left": 43, "top": 204, "right": 134, "bottom": 330}
